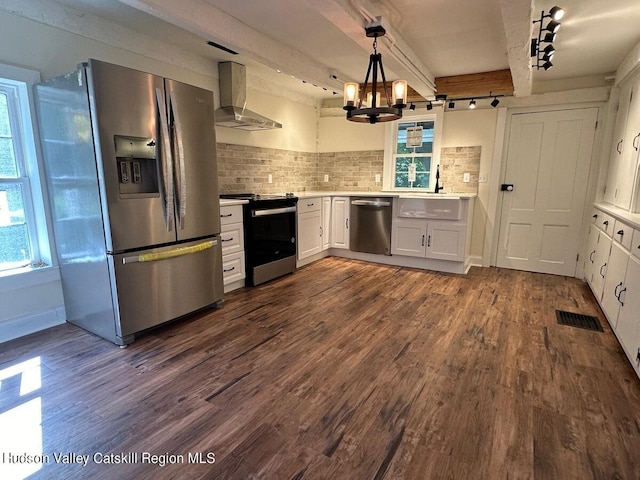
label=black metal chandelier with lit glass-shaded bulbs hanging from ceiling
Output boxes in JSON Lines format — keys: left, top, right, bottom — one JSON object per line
{"left": 342, "top": 22, "right": 407, "bottom": 124}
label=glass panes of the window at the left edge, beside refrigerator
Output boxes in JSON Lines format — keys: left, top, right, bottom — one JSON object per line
{"left": 0, "top": 78, "right": 39, "bottom": 272}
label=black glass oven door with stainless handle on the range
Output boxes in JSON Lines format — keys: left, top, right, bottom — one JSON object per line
{"left": 245, "top": 205, "right": 296, "bottom": 267}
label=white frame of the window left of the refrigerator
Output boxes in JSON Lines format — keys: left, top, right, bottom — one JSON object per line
{"left": 0, "top": 64, "right": 54, "bottom": 277}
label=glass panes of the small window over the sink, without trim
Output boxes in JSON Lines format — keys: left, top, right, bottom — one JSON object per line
{"left": 392, "top": 120, "right": 435, "bottom": 190}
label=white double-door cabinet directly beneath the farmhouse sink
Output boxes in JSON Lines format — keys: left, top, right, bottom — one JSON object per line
{"left": 391, "top": 218, "right": 466, "bottom": 262}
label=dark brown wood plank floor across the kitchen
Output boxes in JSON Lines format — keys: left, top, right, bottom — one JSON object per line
{"left": 0, "top": 258, "right": 640, "bottom": 480}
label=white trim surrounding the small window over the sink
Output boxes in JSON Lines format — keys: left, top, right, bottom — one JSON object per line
{"left": 382, "top": 106, "right": 444, "bottom": 193}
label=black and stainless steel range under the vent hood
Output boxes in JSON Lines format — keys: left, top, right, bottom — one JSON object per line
{"left": 220, "top": 193, "right": 298, "bottom": 286}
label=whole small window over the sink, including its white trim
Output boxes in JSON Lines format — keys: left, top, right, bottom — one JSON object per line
{"left": 383, "top": 109, "right": 443, "bottom": 192}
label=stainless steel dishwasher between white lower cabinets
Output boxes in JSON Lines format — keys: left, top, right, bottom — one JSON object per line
{"left": 349, "top": 197, "right": 392, "bottom": 255}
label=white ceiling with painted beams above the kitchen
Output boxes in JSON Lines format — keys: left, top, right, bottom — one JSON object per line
{"left": 22, "top": 0, "right": 640, "bottom": 98}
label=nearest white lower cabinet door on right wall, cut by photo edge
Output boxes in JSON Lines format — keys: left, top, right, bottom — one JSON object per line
{"left": 616, "top": 258, "right": 640, "bottom": 374}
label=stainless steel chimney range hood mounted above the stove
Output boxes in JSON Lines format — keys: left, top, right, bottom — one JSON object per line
{"left": 215, "top": 62, "right": 282, "bottom": 130}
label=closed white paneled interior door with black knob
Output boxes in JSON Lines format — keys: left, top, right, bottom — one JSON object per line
{"left": 496, "top": 108, "right": 597, "bottom": 276}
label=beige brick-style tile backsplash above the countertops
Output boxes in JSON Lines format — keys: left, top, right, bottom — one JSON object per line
{"left": 218, "top": 143, "right": 481, "bottom": 193}
